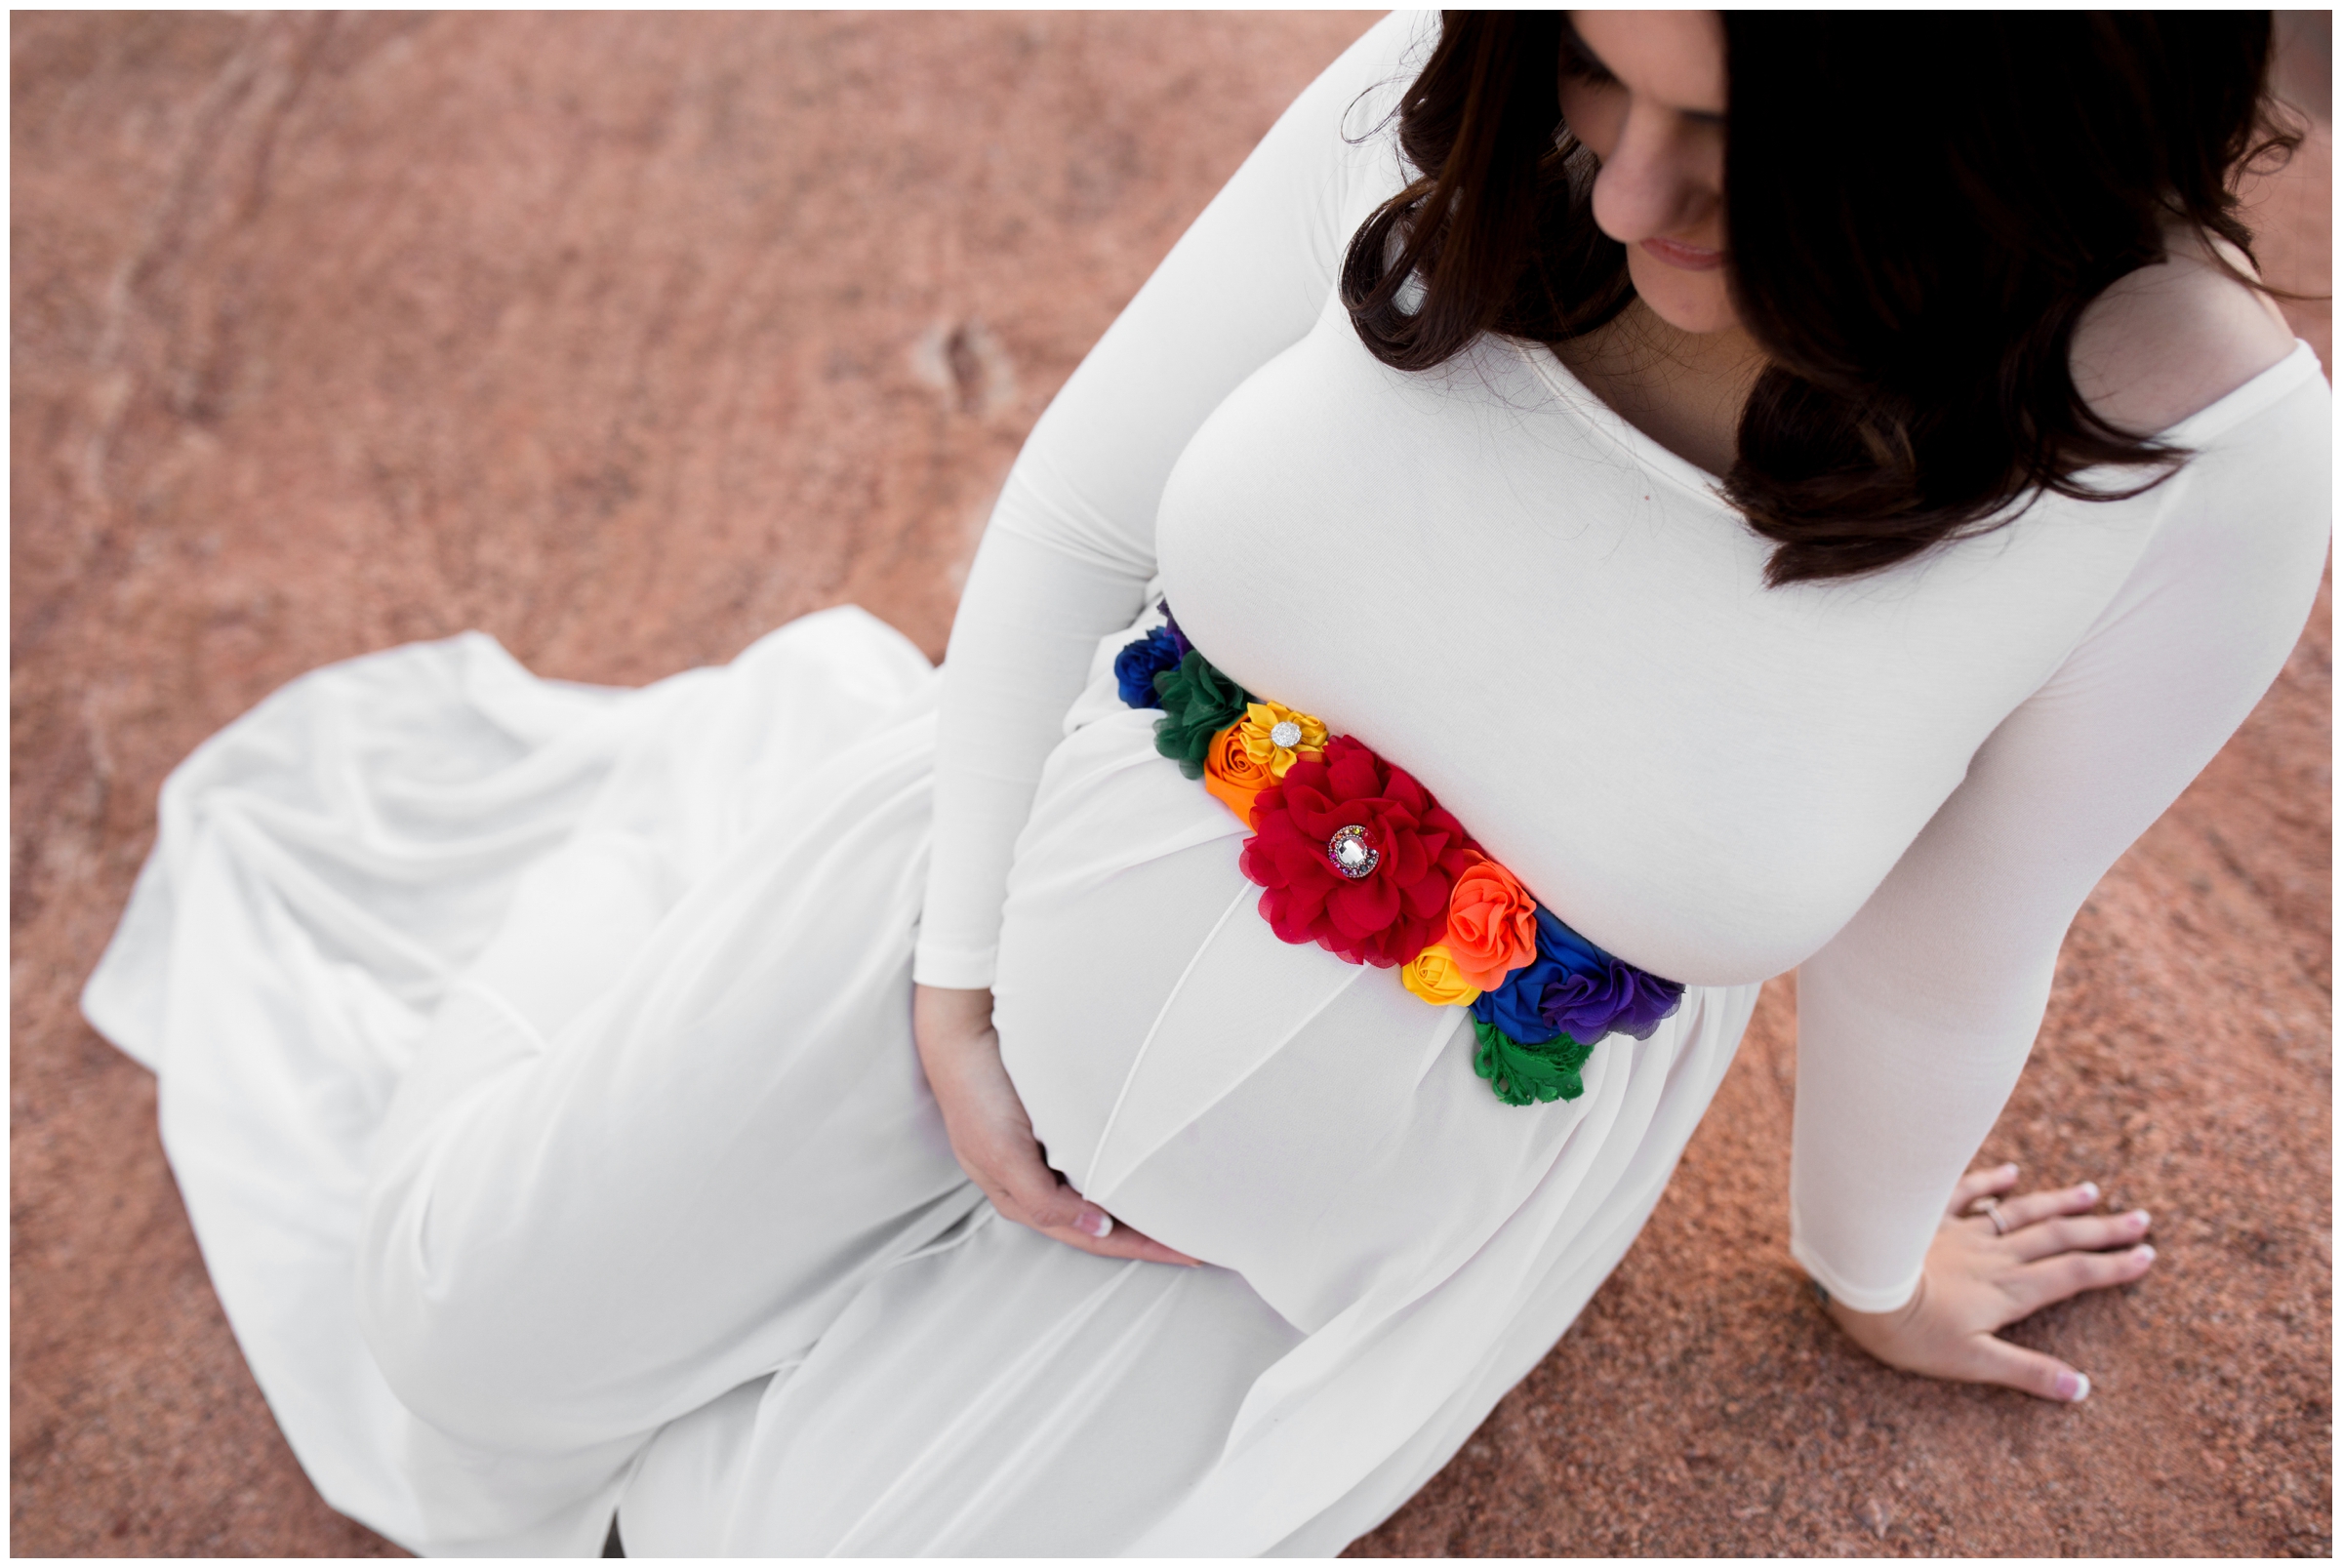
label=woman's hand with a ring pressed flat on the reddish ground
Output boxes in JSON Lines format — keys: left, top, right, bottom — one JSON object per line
{"left": 1827, "top": 1165, "right": 2155, "bottom": 1404}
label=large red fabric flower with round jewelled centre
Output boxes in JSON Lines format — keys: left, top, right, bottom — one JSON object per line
{"left": 1236, "top": 735, "right": 1480, "bottom": 969}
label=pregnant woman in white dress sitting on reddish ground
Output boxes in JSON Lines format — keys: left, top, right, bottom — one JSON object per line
{"left": 87, "top": 12, "right": 2330, "bottom": 1554}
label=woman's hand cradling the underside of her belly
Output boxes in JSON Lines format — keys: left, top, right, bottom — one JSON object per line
{"left": 911, "top": 985, "right": 1194, "bottom": 1264}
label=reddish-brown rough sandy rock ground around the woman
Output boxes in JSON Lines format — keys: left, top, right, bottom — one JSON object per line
{"left": 10, "top": 14, "right": 2332, "bottom": 1554}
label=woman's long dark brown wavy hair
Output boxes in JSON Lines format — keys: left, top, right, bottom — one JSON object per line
{"left": 1342, "top": 12, "right": 2300, "bottom": 583}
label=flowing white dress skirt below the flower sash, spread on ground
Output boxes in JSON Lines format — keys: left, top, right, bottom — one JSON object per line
{"left": 84, "top": 609, "right": 1756, "bottom": 1556}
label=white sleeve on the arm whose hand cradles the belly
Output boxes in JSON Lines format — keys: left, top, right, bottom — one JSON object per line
{"left": 913, "top": 12, "right": 1435, "bottom": 987}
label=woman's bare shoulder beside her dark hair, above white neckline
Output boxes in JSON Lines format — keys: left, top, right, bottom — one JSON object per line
{"left": 2073, "top": 231, "right": 2293, "bottom": 433}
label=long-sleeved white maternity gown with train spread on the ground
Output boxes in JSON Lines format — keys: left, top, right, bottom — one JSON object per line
{"left": 73, "top": 17, "right": 2330, "bottom": 1554}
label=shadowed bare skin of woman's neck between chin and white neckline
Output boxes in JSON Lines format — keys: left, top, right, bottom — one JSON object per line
{"left": 1553, "top": 300, "right": 1763, "bottom": 475}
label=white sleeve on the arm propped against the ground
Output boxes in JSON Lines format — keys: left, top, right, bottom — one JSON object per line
{"left": 1790, "top": 381, "right": 2332, "bottom": 1310}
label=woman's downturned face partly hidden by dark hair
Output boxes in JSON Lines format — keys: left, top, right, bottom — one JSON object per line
{"left": 1562, "top": 12, "right": 1738, "bottom": 333}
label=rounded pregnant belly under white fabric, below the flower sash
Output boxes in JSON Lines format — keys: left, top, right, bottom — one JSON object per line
{"left": 995, "top": 691, "right": 1630, "bottom": 1332}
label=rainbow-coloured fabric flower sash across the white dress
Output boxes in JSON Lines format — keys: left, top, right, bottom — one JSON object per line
{"left": 1114, "top": 604, "right": 1684, "bottom": 1105}
